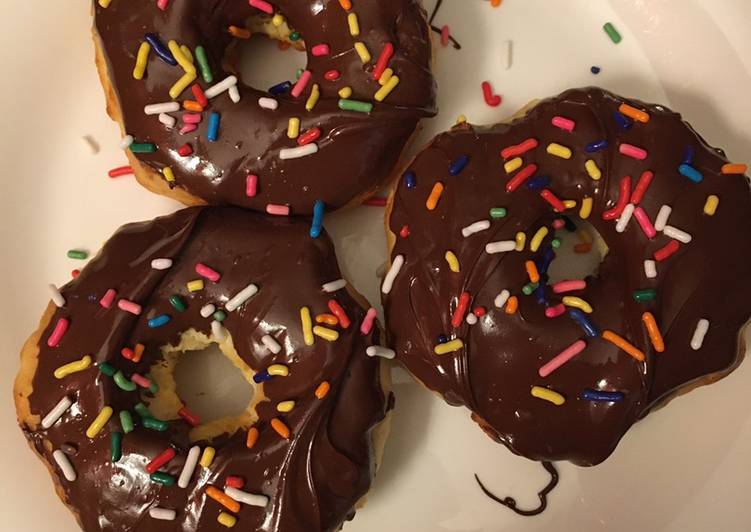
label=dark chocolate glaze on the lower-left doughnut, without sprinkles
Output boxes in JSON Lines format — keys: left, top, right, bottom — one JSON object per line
{"left": 23, "top": 207, "right": 389, "bottom": 532}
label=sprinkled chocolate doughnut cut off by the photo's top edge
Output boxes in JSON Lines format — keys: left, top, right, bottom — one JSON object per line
{"left": 93, "top": 0, "right": 435, "bottom": 214}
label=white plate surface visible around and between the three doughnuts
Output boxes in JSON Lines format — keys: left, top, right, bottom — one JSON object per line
{"left": 0, "top": 0, "right": 751, "bottom": 532}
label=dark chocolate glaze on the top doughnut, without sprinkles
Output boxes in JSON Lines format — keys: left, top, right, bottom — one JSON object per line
{"left": 93, "top": 0, "right": 435, "bottom": 214}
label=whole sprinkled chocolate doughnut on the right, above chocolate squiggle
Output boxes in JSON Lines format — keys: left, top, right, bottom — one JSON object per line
{"left": 383, "top": 88, "right": 751, "bottom": 465}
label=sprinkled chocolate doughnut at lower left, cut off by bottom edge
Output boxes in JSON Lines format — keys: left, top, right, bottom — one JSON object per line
{"left": 14, "top": 207, "right": 392, "bottom": 532}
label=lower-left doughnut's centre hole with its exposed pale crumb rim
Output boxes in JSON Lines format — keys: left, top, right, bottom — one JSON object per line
{"left": 143, "top": 329, "right": 263, "bottom": 441}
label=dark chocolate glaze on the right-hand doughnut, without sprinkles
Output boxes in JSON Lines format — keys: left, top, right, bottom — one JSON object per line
{"left": 384, "top": 88, "right": 751, "bottom": 465}
